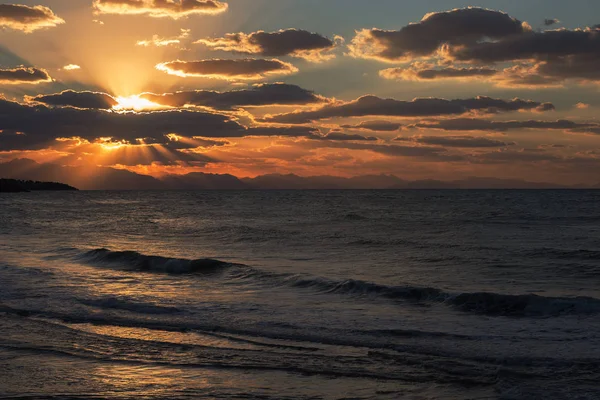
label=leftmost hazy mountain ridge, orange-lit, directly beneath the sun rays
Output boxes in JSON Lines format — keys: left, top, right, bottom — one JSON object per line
{"left": 0, "top": 158, "right": 165, "bottom": 190}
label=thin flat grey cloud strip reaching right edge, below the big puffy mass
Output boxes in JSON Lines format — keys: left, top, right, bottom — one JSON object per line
{"left": 413, "top": 118, "right": 597, "bottom": 132}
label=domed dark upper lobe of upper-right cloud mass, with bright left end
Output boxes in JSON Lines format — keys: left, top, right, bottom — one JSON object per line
{"left": 348, "top": 7, "right": 531, "bottom": 62}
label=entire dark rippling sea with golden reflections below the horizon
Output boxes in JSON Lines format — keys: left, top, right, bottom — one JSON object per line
{"left": 0, "top": 190, "right": 600, "bottom": 399}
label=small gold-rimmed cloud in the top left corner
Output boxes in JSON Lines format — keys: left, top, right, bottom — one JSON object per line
{"left": 0, "top": 4, "right": 65, "bottom": 33}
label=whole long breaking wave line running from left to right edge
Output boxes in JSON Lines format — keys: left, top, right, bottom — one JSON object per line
{"left": 79, "top": 249, "right": 600, "bottom": 317}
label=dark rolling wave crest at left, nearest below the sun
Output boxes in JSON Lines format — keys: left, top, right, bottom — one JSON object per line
{"left": 77, "top": 249, "right": 232, "bottom": 274}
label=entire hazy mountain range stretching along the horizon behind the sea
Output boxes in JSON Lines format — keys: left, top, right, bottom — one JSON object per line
{"left": 0, "top": 159, "right": 600, "bottom": 190}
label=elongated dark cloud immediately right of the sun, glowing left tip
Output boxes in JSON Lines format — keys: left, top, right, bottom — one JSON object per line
{"left": 140, "top": 83, "right": 327, "bottom": 110}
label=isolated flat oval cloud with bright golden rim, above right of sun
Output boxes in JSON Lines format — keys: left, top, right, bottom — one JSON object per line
{"left": 156, "top": 58, "right": 298, "bottom": 80}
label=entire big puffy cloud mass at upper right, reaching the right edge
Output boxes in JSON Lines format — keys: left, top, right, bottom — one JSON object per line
{"left": 349, "top": 7, "right": 600, "bottom": 88}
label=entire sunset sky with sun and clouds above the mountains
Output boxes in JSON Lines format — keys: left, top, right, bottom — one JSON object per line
{"left": 0, "top": 0, "right": 600, "bottom": 184}
